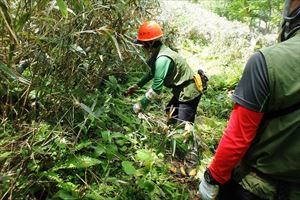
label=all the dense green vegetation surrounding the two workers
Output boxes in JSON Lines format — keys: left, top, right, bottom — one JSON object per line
{"left": 0, "top": 0, "right": 283, "bottom": 199}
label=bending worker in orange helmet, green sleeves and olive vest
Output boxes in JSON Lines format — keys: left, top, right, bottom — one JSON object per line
{"left": 126, "top": 21, "right": 208, "bottom": 128}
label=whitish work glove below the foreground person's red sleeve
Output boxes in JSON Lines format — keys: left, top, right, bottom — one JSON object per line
{"left": 199, "top": 178, "right": 220, "bottom": 200}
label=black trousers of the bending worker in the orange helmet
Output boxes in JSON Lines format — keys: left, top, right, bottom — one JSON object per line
{"left": 166, "top": 95, "right": 201, "bottom": 123}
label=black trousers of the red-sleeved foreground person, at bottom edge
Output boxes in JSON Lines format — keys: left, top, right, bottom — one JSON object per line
{"left": 218, "top": 179, "right": 262, "bottom": 200}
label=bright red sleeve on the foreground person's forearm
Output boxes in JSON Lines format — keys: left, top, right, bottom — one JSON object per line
{"left": 209, "top": 104, "right": 263, "bottom": 184}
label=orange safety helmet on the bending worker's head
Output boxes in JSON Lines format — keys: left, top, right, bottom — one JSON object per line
{"left": 137, "top": 21, "right": 163, "bottom": 42}
